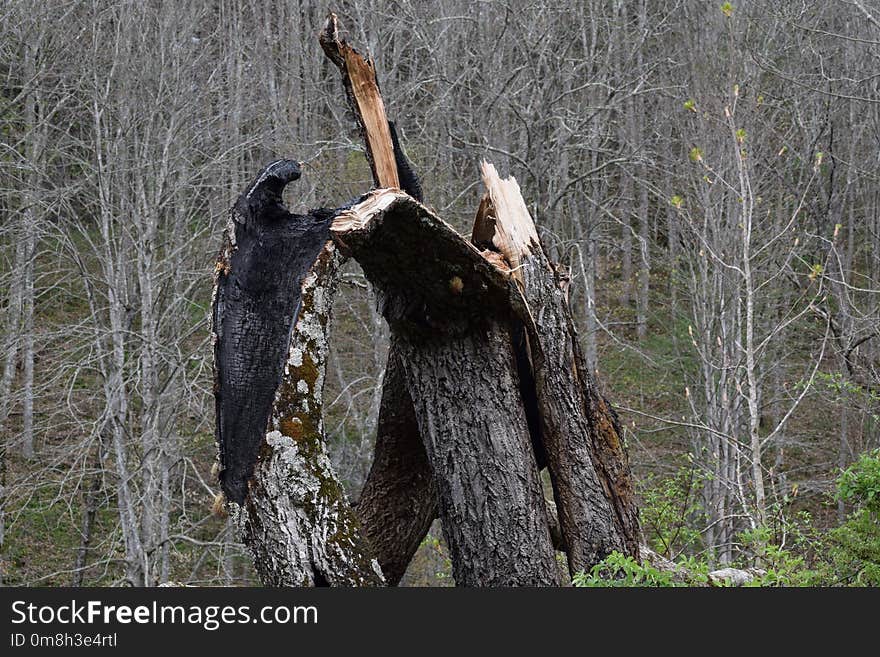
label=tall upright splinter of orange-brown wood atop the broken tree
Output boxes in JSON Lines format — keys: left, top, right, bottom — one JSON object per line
{"left": 319, "top": 13, "right": 400, "bottom": 189}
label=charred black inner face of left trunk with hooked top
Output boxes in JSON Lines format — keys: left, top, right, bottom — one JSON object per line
{"left": 213, "top": 160, "right": 334, "bottom": 504}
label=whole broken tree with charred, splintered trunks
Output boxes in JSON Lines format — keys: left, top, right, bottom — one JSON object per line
{"left": 215, "top": 14, "right": 638, "bottom": 586}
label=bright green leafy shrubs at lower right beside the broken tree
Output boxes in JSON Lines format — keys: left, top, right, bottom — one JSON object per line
{"left": 572, "top": 450, "right": 880, "bottom": 587}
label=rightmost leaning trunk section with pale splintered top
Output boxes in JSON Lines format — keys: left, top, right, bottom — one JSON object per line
{"left": 473, "top": 162, "right": 639, "bottom": 574}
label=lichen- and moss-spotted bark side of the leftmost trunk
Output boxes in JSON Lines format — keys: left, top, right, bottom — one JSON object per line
{"left": 233, "top": 243, "right": 384, "bottom": 586}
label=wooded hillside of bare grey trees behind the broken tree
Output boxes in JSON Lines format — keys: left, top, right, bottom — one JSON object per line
{"left": 0, "top": 0, "right": 880, "bottom": 585}
